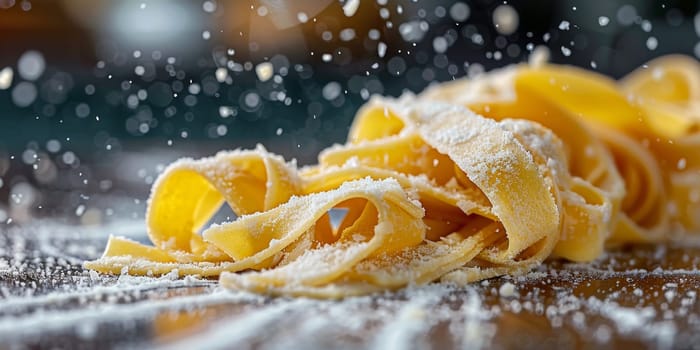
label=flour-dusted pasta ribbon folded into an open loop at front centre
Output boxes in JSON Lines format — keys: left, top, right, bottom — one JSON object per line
{"left": 219, "top": 178, "right": 425, "bottom": 292}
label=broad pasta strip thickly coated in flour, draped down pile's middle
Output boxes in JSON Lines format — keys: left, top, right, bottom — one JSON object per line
{"left": 411, "top": 104, "right": 560, "bottom": 258}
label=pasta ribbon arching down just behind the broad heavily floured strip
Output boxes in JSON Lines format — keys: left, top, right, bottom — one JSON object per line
{"left": 420, "top": 76, "right": 625, "bottom": 261}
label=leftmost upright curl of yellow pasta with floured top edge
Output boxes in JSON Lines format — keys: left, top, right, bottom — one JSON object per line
{"left": 146, "top": 149, "right": 299, "bottom": 251}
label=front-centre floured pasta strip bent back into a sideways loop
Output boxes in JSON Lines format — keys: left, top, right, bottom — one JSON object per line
{"left": 220, "top": 179, "right": 425, "bottom": 291}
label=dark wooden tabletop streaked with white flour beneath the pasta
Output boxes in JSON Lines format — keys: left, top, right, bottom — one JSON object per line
{"left": 0, "top": 221, "right": 700, "bottom": 349}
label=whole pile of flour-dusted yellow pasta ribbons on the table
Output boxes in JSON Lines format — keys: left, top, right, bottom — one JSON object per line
{"left": 85, "top": 56, "right": 700, "bottom": 298}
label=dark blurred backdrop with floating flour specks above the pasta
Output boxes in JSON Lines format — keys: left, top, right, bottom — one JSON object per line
{"left": 0, "top": 0, "right": 700, "bottom": 225}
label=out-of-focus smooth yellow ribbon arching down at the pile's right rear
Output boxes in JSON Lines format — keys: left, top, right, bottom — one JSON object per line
{"left": 514, "top": 66, "right": 670, "bottom": 243}
